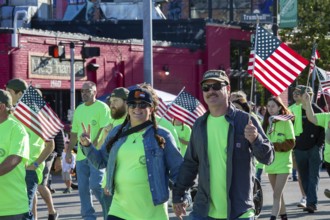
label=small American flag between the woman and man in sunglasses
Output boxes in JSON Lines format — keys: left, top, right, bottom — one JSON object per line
{"left": 168, "top": 91, "right": 206, "bottom": 126}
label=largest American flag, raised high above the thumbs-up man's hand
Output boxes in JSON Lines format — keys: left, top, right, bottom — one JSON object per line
{"left": 248, "top": 26, "right": 308, "bottom": 96}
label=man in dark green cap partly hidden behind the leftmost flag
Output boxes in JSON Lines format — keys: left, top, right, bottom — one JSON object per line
{"left": 6, "top": 78, "right": 57, "bottom": 220}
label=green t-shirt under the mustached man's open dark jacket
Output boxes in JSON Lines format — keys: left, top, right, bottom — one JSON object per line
{"left": 207, "top": 115, "right": 229, "bottom": 218}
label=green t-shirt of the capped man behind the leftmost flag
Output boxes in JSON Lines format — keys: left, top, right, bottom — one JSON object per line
{"left": 13, "top": 116, "right": 45, "bottom": 184}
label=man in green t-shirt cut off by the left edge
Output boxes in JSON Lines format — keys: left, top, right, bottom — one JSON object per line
{"left": 0, "top": 89, "right": 29, "bottom": 220}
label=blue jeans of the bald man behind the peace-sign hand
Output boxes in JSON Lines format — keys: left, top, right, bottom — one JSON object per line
{"left": 76, "top": 159, "right": 105, "bottom": 220}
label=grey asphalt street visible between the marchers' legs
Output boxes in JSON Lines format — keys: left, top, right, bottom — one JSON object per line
{"left": 34, "top": 170, "right": 330, "bottom": 220}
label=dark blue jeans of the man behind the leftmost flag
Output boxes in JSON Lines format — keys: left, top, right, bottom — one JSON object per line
{"left": 25, "top": 170, "right": 38, "bottom": 220}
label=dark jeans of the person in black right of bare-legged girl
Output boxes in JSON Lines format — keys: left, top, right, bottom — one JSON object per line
{"left": 294, "top": 146, "right": 322, "bottom": 206}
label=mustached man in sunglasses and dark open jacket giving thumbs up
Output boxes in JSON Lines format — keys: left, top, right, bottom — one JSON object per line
{"left": 173, "top": 70, "right": 274, "bottom": 220}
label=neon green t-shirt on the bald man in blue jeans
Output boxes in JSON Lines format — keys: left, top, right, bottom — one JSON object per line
{"left": 71, "top": 100, "right": 110, "bottom": 161}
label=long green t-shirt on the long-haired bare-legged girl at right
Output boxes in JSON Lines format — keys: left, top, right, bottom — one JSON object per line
{"left": 265, "top": 121, "right": 295, "bottom": 174}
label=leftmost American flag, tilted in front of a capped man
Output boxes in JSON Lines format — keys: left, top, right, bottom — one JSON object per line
{"left": 14, "top": 85, "right": 64, "bottom": 141}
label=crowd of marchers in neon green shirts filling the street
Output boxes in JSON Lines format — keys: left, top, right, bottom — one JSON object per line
{"left": 0, "top": 70, "right": 330, "bottom": 220}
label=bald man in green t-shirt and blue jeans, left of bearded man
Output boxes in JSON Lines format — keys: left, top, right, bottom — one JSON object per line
{"left": 66, "top": 81, "right": 110, "bottom": 220}
